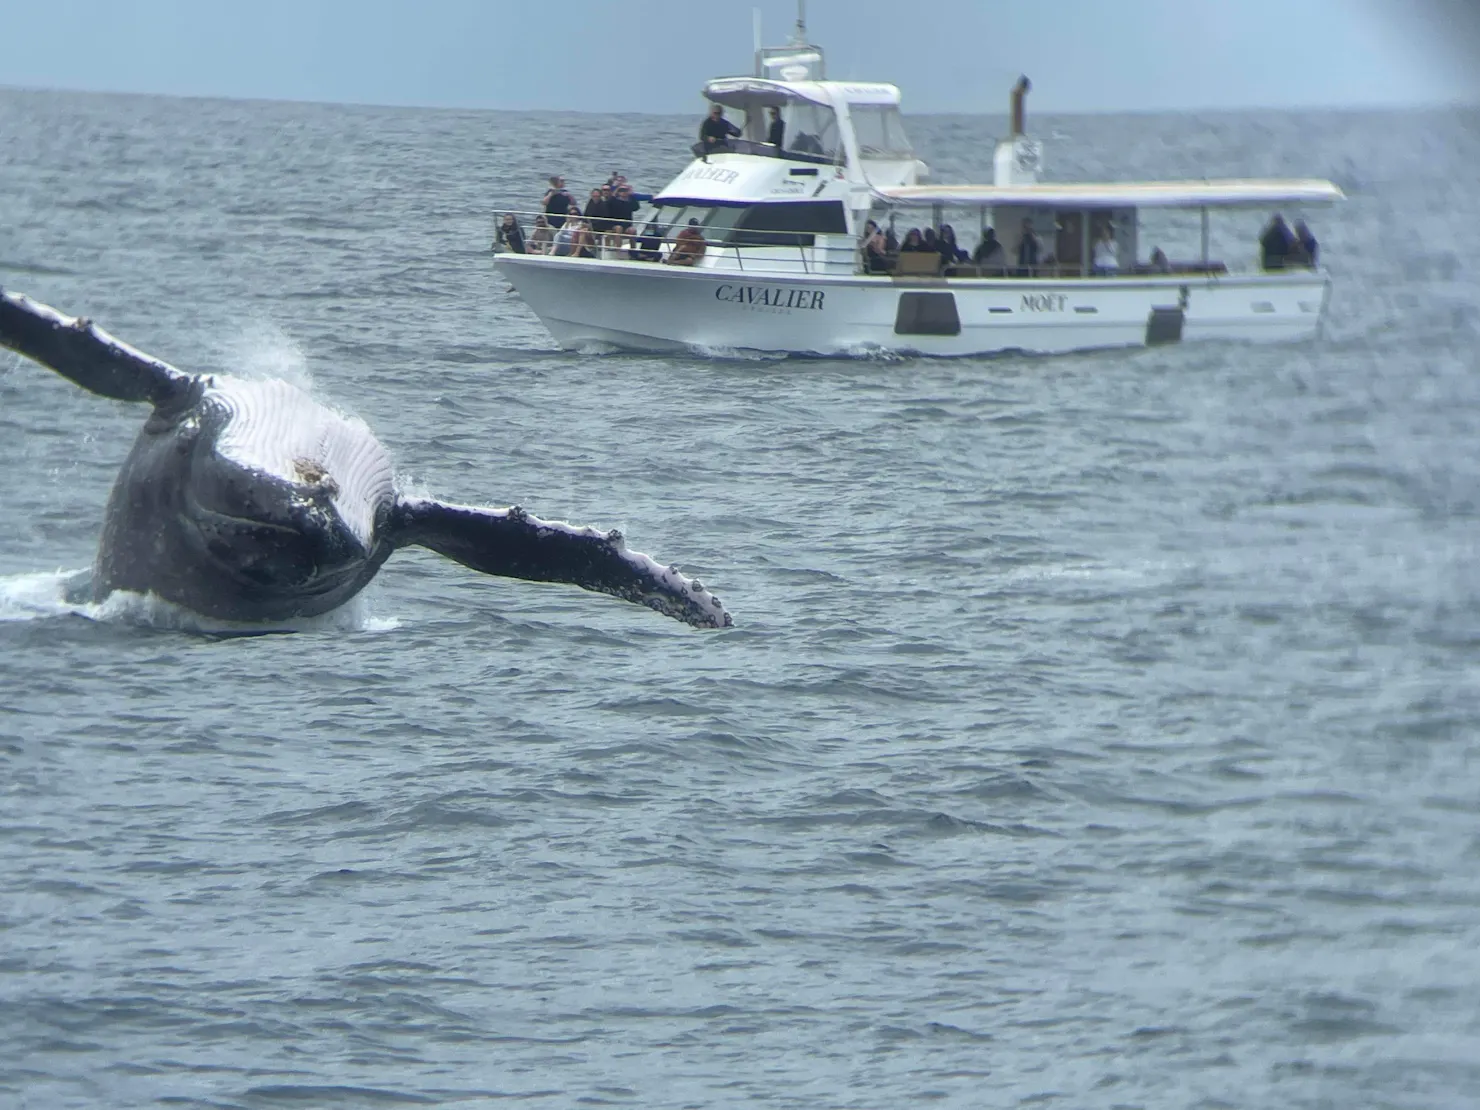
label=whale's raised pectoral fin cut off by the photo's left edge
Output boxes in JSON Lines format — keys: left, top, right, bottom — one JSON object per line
{"left": 0, "top": 289, "right": 195, "bottom": 404}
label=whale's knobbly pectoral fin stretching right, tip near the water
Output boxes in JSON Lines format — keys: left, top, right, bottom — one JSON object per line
{"left": 388, "top": 497, "right": 731, "bottom": 628}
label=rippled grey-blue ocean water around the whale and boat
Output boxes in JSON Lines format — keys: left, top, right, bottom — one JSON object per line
{"left": 0, "top": 90, "right": 1480, "bottom": 1110}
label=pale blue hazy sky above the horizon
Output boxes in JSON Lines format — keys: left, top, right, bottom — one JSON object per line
{"left": 0, "top": 0, "right": 1480, "bottom": 112}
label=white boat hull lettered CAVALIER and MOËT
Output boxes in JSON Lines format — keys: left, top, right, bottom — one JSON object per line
{"left": 497, "top": 255, "right": 1329, "bottom": 355}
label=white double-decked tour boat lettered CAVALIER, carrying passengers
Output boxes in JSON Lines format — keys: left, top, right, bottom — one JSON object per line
{"left": 496, "top": 10, "right": 1342, "bottom": 355}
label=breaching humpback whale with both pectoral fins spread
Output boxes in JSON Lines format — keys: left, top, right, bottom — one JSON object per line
{"left": 0, "top": 290, "right": 731, "bottom": 628}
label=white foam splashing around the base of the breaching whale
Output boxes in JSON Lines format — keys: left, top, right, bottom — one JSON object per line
{"left": 0, "top": 570, "right": 401, "bottom": 636}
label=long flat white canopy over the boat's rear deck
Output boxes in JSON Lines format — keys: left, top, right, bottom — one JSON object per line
{"left": 875, "top": 179, "right": 1347, "bottom": 209}
